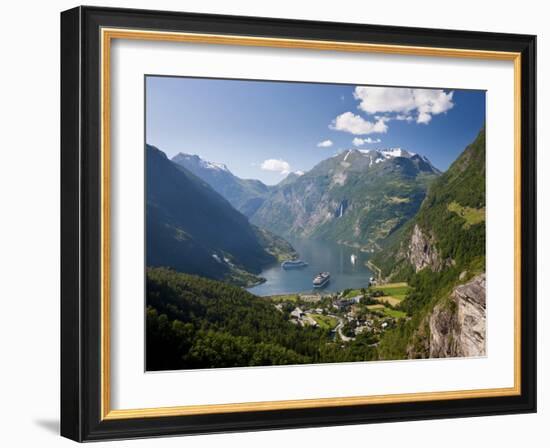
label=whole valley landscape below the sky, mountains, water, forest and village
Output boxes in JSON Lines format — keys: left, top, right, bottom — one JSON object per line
{"left": 147, "top": 125, "right": 485, "bottom": 370}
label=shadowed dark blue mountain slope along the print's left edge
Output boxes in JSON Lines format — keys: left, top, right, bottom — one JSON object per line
{"left": 146, "top": 145, "right": 291, "bottom": 285}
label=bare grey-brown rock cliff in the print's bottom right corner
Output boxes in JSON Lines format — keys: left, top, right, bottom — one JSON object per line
{"left": 429, "top": 274, "right": 486, "bottom": 358}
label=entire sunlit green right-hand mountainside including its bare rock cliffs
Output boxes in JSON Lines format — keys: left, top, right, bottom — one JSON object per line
{"left": 371, "top": 129, "right": 485, "bottom": 359}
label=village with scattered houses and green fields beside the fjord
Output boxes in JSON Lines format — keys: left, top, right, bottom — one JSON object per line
{"left": 270, "top": 283, "right": 410, "bottom": 346}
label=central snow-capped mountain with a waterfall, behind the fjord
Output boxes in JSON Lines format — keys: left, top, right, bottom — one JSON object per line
{"left": 251, "top": 150, "right": 439, "bottom": 249}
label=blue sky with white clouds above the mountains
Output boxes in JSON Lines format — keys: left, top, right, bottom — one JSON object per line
{"left": 146, "top": 76, "right": 485, "bottom": 184}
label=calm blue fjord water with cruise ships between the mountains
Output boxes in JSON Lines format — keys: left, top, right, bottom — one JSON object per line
{"left": 248, "top": 240, "right": 373, "bottom": 296}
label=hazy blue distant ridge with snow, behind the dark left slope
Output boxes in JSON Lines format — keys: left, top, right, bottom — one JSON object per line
{"left": 172, "top": 152, "right": 270, "bottom": 216}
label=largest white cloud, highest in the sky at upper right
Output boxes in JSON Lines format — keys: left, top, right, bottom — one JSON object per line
{"left": 353, "top": 86, "right": 454, "bottom": 124}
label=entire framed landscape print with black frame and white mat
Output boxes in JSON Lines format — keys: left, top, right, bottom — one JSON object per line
{"left": 61, "top": 7, "right": 536, "bottom": 441}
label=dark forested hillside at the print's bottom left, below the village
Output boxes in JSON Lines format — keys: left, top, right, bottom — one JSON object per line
{"left": 147, "top": 268, "right": 376, "bottom": 370}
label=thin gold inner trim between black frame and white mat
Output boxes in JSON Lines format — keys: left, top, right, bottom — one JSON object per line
{"left": 100, "top": 28, "right": 521, "bottom": 420}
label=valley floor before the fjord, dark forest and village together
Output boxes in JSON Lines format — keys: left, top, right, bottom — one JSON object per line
{"left": 146, "top": 268, "right": 408, "bottom": 371}
